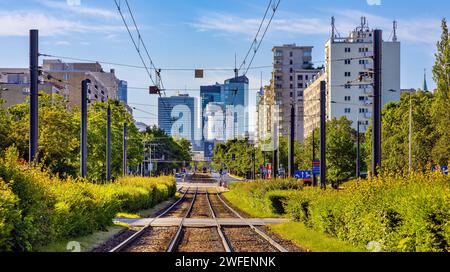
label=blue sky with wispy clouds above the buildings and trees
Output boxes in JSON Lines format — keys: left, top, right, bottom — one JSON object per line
{"left": 0, "top": 0, "right": 450, "bottom": 130}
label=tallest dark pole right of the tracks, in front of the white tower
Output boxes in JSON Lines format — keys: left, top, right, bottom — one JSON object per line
{"left": 372, "top": 29, "right": 383, "bottom": 176}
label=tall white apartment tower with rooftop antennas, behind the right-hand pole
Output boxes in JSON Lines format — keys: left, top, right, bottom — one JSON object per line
{"left": 305, "top": 17, "right": 401, "bottom": 135}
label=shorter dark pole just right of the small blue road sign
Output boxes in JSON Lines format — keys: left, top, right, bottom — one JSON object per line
{"left": 320, "top": 81, "right": 327, "bottom": 189}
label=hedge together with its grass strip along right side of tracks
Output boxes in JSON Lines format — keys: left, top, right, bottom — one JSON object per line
{"left": 225, "top": 173, "right": 450, "bottom": 252}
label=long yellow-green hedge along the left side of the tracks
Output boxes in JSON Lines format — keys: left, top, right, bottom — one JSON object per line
{"left": 0, "top": 149, "right": 176, "bottom": 251}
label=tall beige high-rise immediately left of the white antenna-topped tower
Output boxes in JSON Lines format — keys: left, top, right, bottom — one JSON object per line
{"left": 272, "top": 44, "right": 319, "bottom": 142}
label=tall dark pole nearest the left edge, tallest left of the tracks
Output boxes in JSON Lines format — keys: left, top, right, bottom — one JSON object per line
{"left": 29, "top": 29, "right": 39, "bottom": 165}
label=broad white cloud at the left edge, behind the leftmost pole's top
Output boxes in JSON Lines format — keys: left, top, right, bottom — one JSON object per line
{"left": 0, "top": 11, "right": 123, "bottom": 36}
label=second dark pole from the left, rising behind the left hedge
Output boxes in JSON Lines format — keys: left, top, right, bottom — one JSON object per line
{"left": 80, "top": 79, "right": 90, "bottom": 178}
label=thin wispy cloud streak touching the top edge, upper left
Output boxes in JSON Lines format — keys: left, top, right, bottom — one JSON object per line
{"left": 38, "top": 0, "right": 120, "bottom": 19}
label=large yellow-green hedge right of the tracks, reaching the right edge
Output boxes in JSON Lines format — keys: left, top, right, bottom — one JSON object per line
{"left": 286, "top": 173, "right": 450, "bottom": 252}
